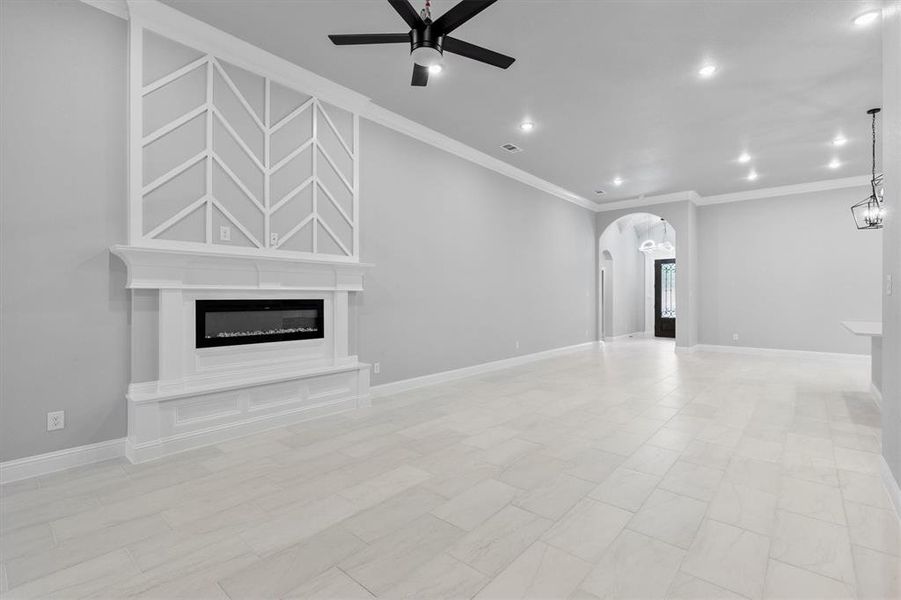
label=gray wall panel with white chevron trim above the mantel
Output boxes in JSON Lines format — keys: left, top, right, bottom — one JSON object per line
{"left": 129, "top": 24, "right": 359, "bottom": 261}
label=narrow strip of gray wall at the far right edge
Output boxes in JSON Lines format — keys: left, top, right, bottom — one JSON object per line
{"left": 881, "top": 0, "right": 901, "bottom": 492}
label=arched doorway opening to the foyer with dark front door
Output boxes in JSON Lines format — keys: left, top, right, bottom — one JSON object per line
{"left": 598, "top": 212, "right": 676, "bottom": 340}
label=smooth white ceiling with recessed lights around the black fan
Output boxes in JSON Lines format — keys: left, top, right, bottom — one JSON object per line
{"left": 166, "top": 0, "right": 881, "bottom": 202}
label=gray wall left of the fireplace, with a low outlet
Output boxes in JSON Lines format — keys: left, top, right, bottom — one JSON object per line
{"left": 0, "top": 1, "right": 129, "bottom": 460}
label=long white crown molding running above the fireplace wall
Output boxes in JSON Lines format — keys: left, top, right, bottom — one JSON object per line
{"left": 81, "top": 0, "right": 597, "bottom": 211}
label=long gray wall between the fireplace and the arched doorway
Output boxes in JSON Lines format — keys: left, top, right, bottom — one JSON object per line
{"left": 355, "top": 120, "right": 597, "bottom": 384}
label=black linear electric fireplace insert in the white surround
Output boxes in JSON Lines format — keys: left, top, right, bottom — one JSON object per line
{"left": 195, "top": 300, "right": 325, "bottom": 348}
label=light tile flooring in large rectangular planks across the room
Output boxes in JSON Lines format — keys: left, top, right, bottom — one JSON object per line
{"left": 0, "top": 340, "right": 901, "bottom": 599}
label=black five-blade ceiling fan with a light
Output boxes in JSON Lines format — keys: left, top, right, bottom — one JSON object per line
{"left": 329, "top": 0, "right": 516, "bottom": 86}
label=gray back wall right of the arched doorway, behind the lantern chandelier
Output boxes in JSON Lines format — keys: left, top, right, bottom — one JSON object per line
{"left": 700, "top": 188, "right": 882, "bottom": 354}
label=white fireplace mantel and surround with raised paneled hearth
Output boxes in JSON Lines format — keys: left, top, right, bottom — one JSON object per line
{"left": 110, "top": 245, "right": 372, "bottom": 462}
